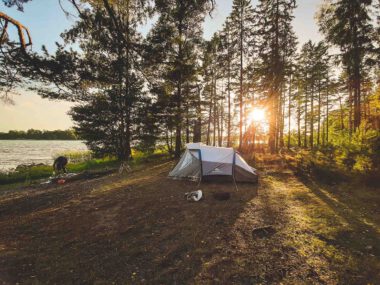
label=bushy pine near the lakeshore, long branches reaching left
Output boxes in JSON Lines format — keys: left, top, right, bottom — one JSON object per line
{"left": 12, "top": 0, "right": 149, "bottom": 160}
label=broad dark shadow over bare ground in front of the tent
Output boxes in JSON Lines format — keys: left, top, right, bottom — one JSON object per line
{"left": 0, "top": 165, "right": 257, "bottom": 283}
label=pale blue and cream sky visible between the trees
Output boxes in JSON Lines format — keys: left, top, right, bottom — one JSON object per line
{"left": 0, "top": 0, "right": 322, "bottom": 132}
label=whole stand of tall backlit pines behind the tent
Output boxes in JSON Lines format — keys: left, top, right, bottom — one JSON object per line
{"left": 0, "top": 0, "right": 380, "bottom": 160}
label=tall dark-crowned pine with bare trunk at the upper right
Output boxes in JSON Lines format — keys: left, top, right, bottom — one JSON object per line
{"left": 318, "top": 0, "right": 374, "bottom": 130}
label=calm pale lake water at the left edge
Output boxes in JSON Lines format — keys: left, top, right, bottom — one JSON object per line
{"left": 0, "top": 140, "right": 87, "bottom": 171}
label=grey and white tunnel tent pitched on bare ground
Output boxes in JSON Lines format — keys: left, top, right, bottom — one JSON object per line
{"left": 169, "top": 143, "right": 258, "bottom": 182}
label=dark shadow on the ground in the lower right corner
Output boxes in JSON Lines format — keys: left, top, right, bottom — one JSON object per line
{"left": 299, "top": 177, "right": 380, "bottom": 284}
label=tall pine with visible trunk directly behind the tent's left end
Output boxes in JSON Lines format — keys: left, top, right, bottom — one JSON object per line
{"left": 146, "top": 0, "right": 210, "bottom": 157}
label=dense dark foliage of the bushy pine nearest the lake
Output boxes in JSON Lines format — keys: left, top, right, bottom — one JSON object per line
{"left": 63, "top": 1, "right": 155, "bottom": 160}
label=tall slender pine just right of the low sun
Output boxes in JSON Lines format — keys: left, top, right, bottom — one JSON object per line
{"left": 256, "top": 0, "right": 296, "bottom": 152}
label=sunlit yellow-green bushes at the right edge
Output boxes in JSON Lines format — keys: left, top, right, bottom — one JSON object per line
{"left": 295, "top": 127, "right": 380, "bottom": 184}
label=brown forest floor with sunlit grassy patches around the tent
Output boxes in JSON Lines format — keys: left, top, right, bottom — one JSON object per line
{"left": 0, "top": 154, "right": 380, "bottom": 284}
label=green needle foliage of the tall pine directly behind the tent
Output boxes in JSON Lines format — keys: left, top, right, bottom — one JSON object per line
{"left": 145, "top": 0, "right": 210, "bottom": 157}
